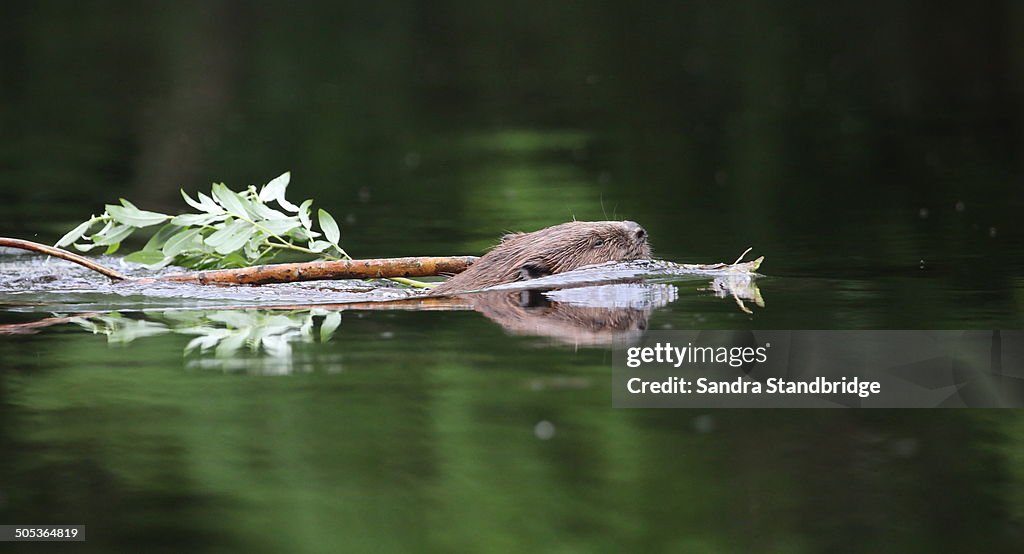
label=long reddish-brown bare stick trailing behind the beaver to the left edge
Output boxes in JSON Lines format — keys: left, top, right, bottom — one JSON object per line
{"left": 0, "top": 237, "right": 477, "bottom": 285}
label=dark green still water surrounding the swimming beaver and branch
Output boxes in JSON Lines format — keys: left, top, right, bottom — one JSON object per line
{"left": 0, "top": 2, "right": 1024, "bottom": 553}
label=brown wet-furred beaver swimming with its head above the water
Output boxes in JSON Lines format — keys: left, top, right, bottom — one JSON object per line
{"left": 430, "top": 221, "right": 650, "bottom": 296}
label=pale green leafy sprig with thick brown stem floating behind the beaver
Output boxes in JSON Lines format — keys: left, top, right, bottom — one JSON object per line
{"left": 37, "top": 173, "right": 452, "bottom": 288}
